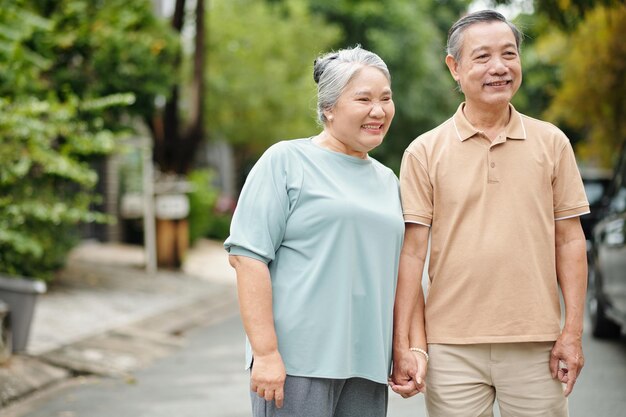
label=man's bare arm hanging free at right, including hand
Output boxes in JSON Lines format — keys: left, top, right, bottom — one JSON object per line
{"left": 550, "top": 217, "right": 587, "bottom": 396}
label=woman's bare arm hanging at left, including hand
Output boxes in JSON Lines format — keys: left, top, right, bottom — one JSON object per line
{"left": 228, "top": 255, "right": 286, "bottom": 408}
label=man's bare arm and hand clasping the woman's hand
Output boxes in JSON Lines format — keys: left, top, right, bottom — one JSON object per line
{"left": 390, "top": 223, "right": 430, "bottom": 398}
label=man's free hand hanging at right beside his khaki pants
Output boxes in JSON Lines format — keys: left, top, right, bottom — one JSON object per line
{"left": 550, "top": 331, "right": 585, "bottom": 397}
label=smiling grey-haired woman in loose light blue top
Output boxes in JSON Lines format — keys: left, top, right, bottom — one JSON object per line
{"left": 224, "top": 46, "right": 404, "bottom": 417}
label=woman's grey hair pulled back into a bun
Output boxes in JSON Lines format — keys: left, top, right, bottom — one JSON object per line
{"left": 313, "top": 45, "right": 391, "bottom": 125}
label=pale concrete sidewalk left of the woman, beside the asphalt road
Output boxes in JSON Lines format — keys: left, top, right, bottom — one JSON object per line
{"left": 0, "top": 240, "right": 237, "bottom": 414}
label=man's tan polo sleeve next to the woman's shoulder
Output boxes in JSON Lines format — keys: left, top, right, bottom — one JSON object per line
{"left": 400, "top": 146, "right": 433, "bottom": 226}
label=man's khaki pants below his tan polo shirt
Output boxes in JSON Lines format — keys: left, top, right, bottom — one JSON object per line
{"left": 426, "top": 342, "right": 568, "bottom": 417}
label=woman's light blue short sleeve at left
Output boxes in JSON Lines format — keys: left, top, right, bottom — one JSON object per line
{"left": 224, "top": 142, "right": 302, "bottom": 264}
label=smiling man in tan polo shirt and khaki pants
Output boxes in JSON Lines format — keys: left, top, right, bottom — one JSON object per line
{"left": 390, "top": 10, "right": 589, "bottom": 417}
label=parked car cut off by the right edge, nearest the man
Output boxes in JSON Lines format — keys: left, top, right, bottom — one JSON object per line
{"left": 587, "top": 152, "right": 626, "bottom": 338}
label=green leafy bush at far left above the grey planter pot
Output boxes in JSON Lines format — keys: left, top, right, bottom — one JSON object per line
{"left": 0, "top": 0, "right": 133, "bottom": 279}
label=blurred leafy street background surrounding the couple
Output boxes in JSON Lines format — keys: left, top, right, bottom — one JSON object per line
{"left": 0, "top": 0, "right": 626, "bottom": 417}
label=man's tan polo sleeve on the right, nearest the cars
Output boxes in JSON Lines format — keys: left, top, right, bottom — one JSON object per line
{"left": 552, "top": 138, "right": 589, "bottom": 220}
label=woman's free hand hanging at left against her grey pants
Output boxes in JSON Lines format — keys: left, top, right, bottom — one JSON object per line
{"left": 250, "top": 350, "right": 287, "bottom": 408}
